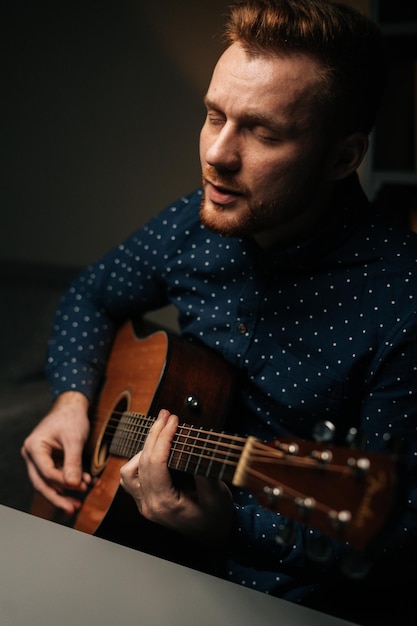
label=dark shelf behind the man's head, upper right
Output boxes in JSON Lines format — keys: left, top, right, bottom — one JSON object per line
{"left": 362, "top": 0, "right": 417, "bottom": 217}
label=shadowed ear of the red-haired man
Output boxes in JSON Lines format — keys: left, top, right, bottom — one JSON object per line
{"left": 328, "top": 132, "right": 368, "bottom": 181}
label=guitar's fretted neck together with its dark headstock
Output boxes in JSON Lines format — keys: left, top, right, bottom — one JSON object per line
{"left": 104, "top": 412, "right": 396, "bottom": 549}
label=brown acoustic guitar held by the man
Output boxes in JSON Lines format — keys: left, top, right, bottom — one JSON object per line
{"left": 32, "top": 321, "right": 397, "bottom": 550}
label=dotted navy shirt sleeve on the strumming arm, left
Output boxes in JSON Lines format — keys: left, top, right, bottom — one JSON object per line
{"left": 46, "top": 202, "right": 186, "bottom": 400}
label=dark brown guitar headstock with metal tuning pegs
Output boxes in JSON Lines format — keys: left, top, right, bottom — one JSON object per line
{"left": 233, "top": 437, "right": 396, "bottom": 550}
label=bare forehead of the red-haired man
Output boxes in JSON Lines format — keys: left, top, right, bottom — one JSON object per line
{"left": 207, "top": 43, "right": 320, "bottom": 122}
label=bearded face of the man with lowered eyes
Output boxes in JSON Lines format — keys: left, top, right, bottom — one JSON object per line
{"left": 200, "top": 43, "right": 336, "bottom": 246}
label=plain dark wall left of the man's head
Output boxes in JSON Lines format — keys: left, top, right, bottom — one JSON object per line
{"left": 0, "top": 0, "right": 227, "bottom": 266}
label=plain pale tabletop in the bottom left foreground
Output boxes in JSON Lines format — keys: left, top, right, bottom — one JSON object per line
{"left": 0, "top": 506, "right": 349, "bottom": 626}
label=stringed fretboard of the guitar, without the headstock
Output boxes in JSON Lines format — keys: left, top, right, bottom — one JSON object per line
{"left": 109, "top": 412, "right": 247, "bottom": 483}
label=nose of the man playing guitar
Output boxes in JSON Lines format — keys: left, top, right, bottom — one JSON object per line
{"left": 202, "top": 123, "right": 241, "bottom": 172}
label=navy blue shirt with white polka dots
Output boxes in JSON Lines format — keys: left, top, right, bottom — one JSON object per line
{"left": 47, "top": 177, "right": 417, "bottom": 601}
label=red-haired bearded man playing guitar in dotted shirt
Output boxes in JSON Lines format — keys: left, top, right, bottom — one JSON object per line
{"left": 23, "top": 0, "right": 417, "bottom": 623}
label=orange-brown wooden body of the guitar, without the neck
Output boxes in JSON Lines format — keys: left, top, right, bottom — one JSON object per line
{"left": 31, "top": 321, "right": 233, "bottom": 534}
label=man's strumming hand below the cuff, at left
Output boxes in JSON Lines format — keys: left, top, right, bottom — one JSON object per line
{"left": 22, "top": 391, "right": 91, "bottom": 515}
